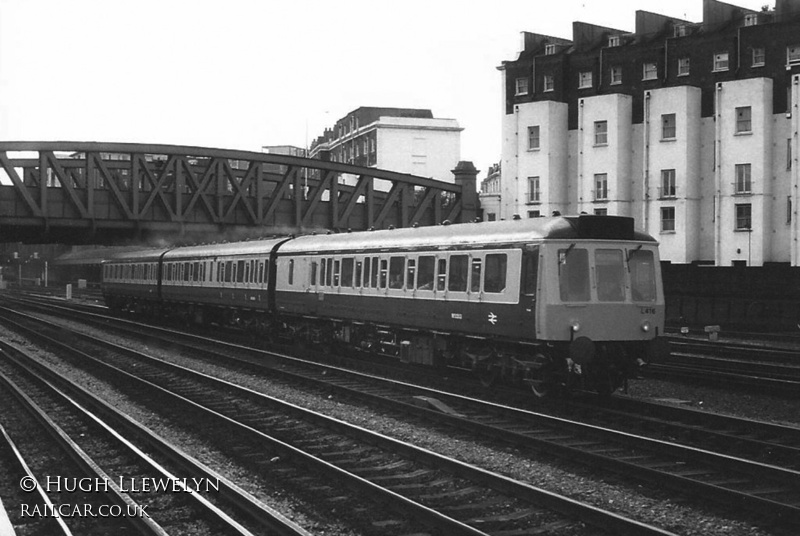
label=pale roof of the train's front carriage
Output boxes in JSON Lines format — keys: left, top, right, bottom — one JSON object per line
{"left": 279, "top": 215, "right": 657, "bottom": 254}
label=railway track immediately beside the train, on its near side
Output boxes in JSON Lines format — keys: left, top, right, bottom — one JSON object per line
{"left": 1, "top": 298, "right": 800, "bottom": 524}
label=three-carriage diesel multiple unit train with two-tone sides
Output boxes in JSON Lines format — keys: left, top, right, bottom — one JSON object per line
{"left": 102, "top": 215, "right": 664, "bottom": 397}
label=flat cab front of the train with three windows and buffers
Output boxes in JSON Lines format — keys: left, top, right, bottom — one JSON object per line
{"left": 537, "top": 240, "right": 669, "bottom": 394}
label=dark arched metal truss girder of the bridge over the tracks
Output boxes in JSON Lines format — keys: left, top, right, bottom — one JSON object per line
{"left": 0, "top": 142, "right": 475, "bottom": 243}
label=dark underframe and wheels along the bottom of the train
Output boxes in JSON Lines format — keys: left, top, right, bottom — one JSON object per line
{"left": 106, "top": 298, "right": 657, "bottom": 398}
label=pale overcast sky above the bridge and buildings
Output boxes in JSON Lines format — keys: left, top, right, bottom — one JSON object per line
{"left": 0, "top": 0, "right": 774, "bottom": 178}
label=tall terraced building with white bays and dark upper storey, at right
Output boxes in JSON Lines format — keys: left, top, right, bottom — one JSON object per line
{"left": 496, "top": 0, "right": 800, "bottom": 266}
